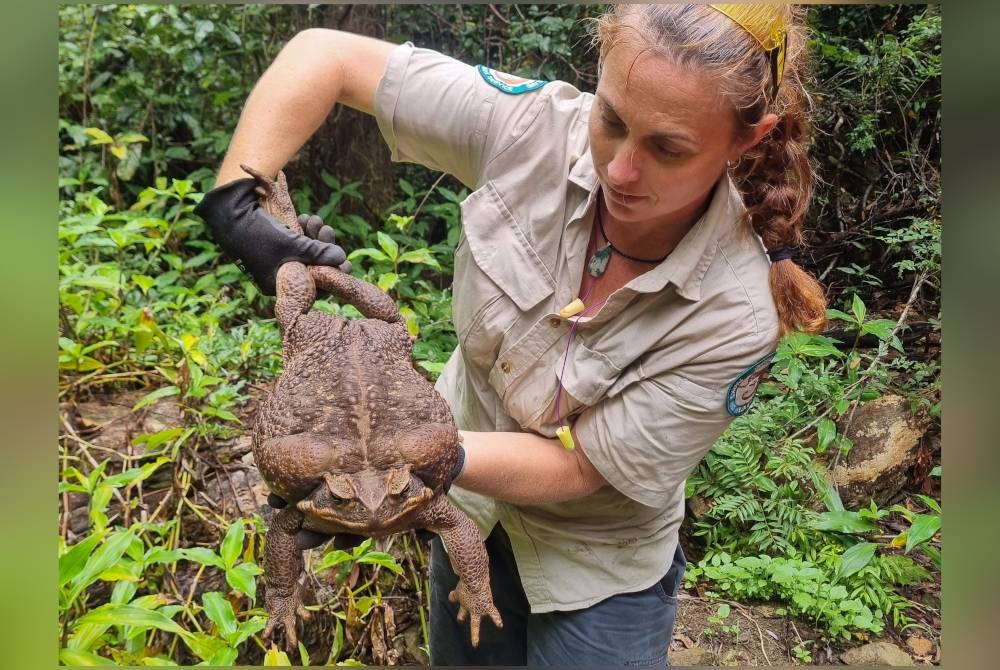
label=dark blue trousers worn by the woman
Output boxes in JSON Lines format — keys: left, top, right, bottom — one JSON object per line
{"left": 429, "top": 525, "right": 685, "bottom": 667}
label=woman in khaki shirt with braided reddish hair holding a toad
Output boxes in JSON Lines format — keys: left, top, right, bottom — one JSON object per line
{"left": 198, "top": 5, "right": 825, "bottom": 665}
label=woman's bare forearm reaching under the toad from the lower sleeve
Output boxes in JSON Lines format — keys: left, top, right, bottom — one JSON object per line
{"left": 455, "top": 431, "right": 607, "bottom": 504}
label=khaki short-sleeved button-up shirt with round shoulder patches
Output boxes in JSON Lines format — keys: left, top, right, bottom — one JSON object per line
{"left": 375, "top": 44, "right": 777, "bottom": 612}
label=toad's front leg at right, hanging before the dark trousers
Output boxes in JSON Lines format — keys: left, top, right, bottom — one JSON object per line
{"left": 418, "top": 495, "right": 503, "bottom": 647}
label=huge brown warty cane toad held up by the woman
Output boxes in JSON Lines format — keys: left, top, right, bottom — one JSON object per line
{"left": 243, "top": 166, "right": 502, "bottom": 647}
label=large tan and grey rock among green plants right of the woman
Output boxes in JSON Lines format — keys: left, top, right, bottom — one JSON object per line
{"left": 832, "top": 395, "right": 926, "bottom": 509}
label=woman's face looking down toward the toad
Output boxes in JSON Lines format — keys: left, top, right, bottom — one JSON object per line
{"left": 589, "top": 41, "right": 753, "bottom": 232}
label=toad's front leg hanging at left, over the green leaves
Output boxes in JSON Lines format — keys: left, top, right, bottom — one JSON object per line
{"left": 264, "top": 505, "right": 311, "bottom": 650}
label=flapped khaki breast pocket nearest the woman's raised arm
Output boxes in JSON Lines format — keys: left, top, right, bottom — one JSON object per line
{"left": 452, "top": 182, "right": 555, "bottom": 362}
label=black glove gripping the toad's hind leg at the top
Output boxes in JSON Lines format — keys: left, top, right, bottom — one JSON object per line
{"left": 194, "top": 178, "right": 347, "bottom": 295}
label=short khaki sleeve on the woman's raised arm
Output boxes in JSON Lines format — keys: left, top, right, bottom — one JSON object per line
{"left": 375, "top": 43, "right": 539, "bottom": 188}
